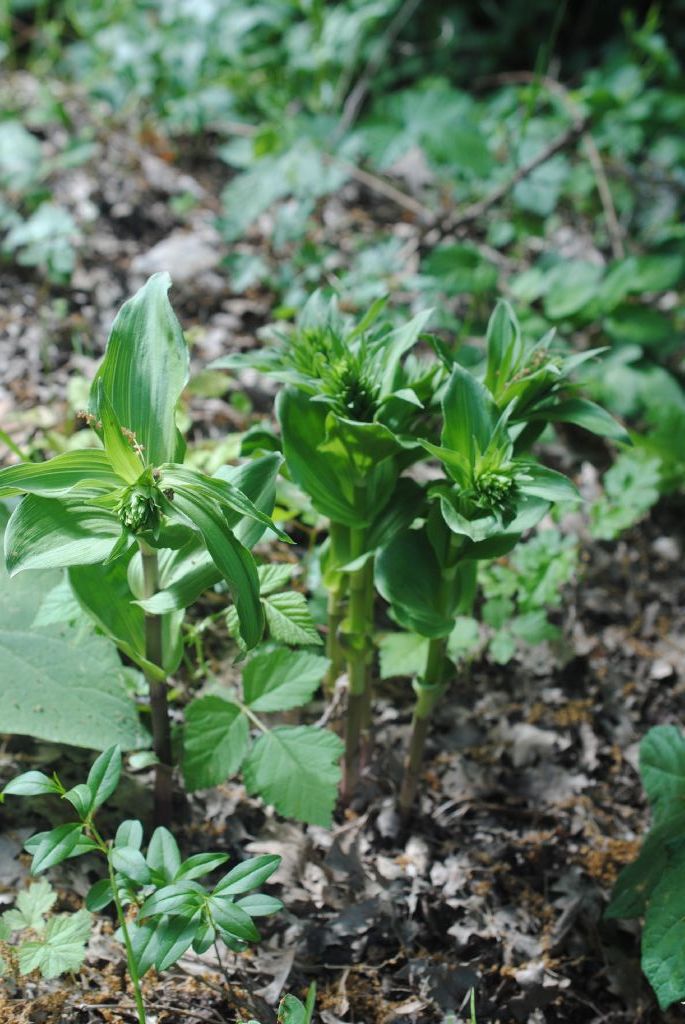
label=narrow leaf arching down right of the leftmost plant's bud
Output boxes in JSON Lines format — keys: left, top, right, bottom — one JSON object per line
{"left": 170, "top": 488, "right": 264, "bottom": 648}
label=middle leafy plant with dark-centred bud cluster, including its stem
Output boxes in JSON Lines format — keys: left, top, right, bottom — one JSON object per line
{"left": 213, "top": 293, "right": 442, "bottom": 796}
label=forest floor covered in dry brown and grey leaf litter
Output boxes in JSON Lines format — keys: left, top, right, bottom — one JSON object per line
{"left": 0, "top": 81, "right": 685, "bottom": 1024}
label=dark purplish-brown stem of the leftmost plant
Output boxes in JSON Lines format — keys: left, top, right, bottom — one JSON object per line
{"left": 140, "top": 544, "right": 172, "bottom": 825}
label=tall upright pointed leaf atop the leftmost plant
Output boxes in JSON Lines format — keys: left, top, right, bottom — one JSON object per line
{"left": 91, "top": 273, "right": 188, "bottom": 466}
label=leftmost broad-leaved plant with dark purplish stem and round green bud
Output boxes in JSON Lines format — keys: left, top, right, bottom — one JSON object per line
{"left": 0, "top": 273, "right": 287, "bottom": 819}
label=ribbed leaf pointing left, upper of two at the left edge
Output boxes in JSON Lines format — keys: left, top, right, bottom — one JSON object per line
{"left": 0, "top": 449, "right": 123, "bottom": 498}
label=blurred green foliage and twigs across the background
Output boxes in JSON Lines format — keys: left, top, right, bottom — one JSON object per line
{"left": 0, "top": 0, "right": 685, "bottom": 561}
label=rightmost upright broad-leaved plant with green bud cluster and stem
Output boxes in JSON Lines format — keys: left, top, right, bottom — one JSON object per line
{"left": 376, "top": 303, "right": 627, "bottom": 817}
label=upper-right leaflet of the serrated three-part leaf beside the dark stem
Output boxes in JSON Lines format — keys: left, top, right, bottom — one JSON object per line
{"left": 243, "top": 647, "right": 330, "bottom": 712}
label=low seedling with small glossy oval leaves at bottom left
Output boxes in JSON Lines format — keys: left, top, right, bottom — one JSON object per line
{"left": 0, "top": 746, "right": 283, "bottom": 1024}
